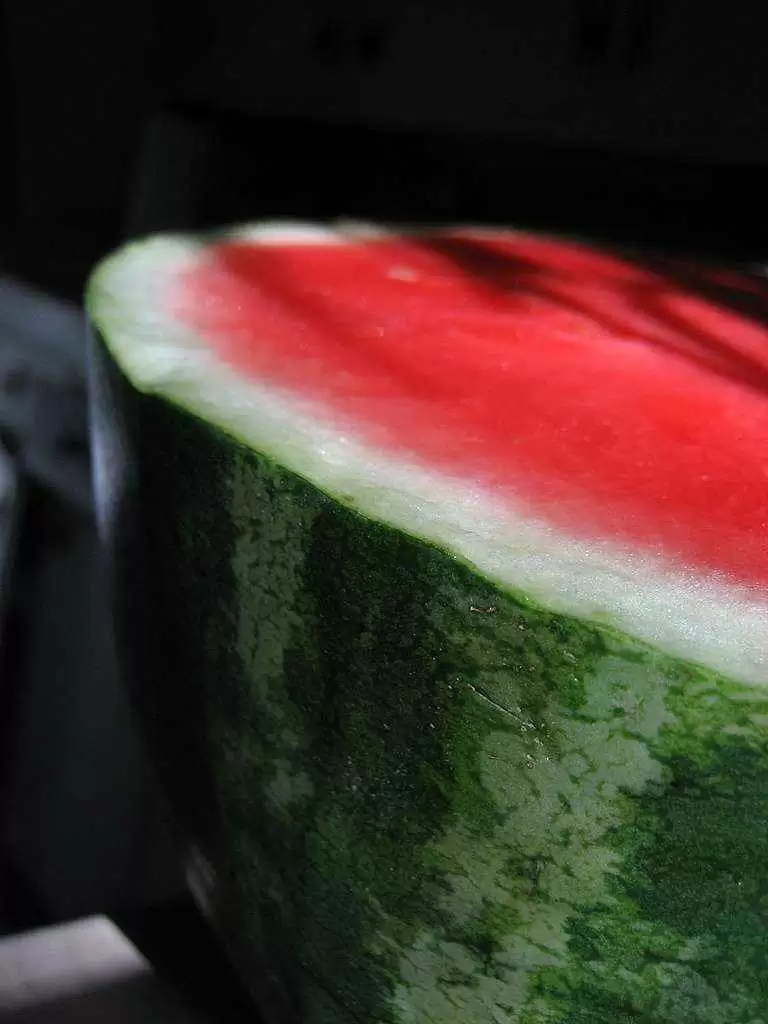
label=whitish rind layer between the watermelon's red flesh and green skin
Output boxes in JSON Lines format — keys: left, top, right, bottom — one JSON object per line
{"left": 88, "top": 224, "right": 768, "bottom": 684}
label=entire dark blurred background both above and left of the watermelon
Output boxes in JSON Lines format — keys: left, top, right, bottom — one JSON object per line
{"left": 0, "top": 0, "right": 768, "bottom": 1019}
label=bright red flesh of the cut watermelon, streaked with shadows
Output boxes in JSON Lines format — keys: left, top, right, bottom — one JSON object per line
{"left": 173, "top": 230, "right": 768, "bottom": 586}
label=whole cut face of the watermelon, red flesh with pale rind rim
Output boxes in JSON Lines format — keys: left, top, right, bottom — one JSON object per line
{"left": 91, "top": 225, "right": 768, "bottom": 680}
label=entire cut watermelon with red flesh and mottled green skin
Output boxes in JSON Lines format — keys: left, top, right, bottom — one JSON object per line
{"left": 87, "top": 223, "right": 768, "bottom": 1024}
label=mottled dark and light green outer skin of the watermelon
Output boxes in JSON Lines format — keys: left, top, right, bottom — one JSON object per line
{"left": 91, "top": 337, "right": 768, "bottom": 1024}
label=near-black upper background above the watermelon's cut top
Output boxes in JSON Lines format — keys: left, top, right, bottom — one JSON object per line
{"left": 0, "top": 0, "right": 768, "bottom": 297}
